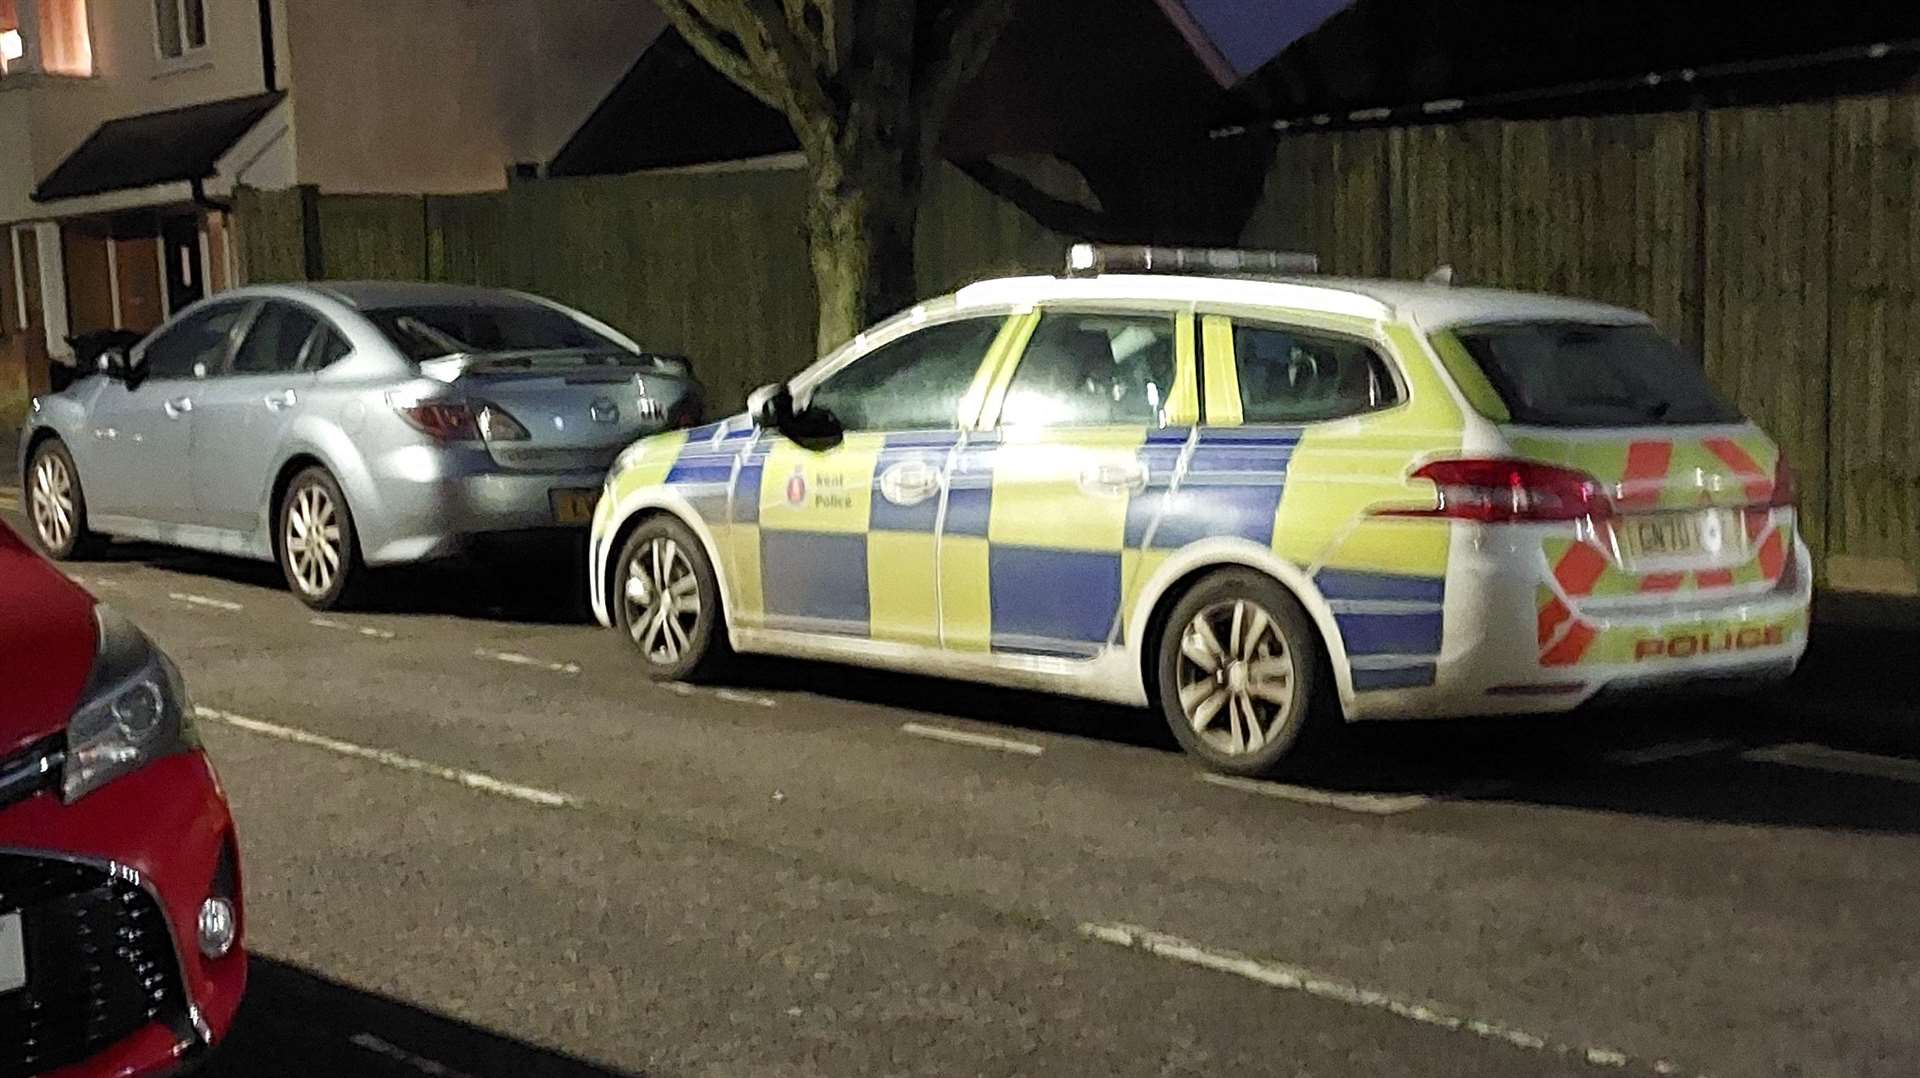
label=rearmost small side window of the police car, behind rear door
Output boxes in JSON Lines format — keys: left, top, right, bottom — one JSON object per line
{"left": 1233, "top": 325, "right": 1400, "bottom": 423}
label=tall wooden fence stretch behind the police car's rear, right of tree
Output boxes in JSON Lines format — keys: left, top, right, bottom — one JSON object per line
{"left": 1242, "top": 96, "right": 1920, "bottom": 594}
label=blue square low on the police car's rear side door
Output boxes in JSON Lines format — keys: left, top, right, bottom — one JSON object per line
{"left": 987, "top": 544, "right": 1119, "bottom": 651}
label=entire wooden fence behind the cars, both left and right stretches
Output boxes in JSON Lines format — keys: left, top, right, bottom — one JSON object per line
{"left": 238, "top": 96, "right": 1920, "bottom": 594}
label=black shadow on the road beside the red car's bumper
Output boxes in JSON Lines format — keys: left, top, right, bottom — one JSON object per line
{"left": 207, "top": 955, "right": 641, "bottom": 1078}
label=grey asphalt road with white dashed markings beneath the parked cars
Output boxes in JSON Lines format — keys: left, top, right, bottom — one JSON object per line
{"left": 0, "top": 490, "right": 1920, "bottom": 1078}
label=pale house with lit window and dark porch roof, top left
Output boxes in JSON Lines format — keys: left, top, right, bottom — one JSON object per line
{"left": 0, "top": 0, "right": 660, "bottom": 425}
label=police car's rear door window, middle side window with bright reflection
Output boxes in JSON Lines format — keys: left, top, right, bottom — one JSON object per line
{"left": 1000, "top": 311, "right": 1175, "bottom": 427}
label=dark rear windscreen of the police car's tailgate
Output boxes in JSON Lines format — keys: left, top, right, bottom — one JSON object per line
{"left": 1455, "top": 323, "right": 1740, "bottom": 427}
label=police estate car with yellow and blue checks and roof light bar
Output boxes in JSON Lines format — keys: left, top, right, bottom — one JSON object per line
{"left": 591, "top": 246, "right": 1811, "bottom": 774}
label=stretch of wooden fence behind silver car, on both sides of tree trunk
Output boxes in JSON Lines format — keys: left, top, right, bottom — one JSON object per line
{"left": 236, "top": 169, "right": 1068, "bottom": 407}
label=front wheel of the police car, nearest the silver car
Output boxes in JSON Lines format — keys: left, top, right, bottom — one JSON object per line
{"left": 611, "top": 517, "right": 732, "bottom": 680}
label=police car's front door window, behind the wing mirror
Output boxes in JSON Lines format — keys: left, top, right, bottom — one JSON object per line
{"left": 810, "top": 315, "right": 1006, "bottom": 430}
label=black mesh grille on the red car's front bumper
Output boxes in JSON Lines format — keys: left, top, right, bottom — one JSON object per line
{"left": 0, "top": 853, "right": 186, "bottom": 1078}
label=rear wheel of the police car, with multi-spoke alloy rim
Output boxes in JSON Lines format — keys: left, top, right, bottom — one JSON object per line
{"left": 1158, "top": 569, "right": 1325, "bottom": 776}
